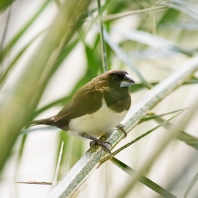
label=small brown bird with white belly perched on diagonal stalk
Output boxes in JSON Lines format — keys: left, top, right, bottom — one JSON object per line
{"left": 31, "top": 70, "right": 135, "bottom": 153}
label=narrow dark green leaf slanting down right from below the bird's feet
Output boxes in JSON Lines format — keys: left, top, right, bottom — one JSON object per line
{"left": 111, "top": 157, "right": 177, "bottom": 198}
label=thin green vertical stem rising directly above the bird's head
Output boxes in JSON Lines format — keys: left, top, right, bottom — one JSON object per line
{"left": 98, "top": 0, "right": 108, "bottom": 72}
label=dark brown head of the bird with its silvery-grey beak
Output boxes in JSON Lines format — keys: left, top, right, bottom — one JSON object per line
{"left": 95, "top": 70, "right": 135, "bottom": 90}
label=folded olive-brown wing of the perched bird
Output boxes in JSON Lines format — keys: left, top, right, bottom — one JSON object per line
{"left": 54, "top": 87, "right": 102, "bottom": 122}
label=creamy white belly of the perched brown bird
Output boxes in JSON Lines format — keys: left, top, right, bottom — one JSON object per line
{"left": 68, "top": 100, "right": 127, "bottom": 137}
